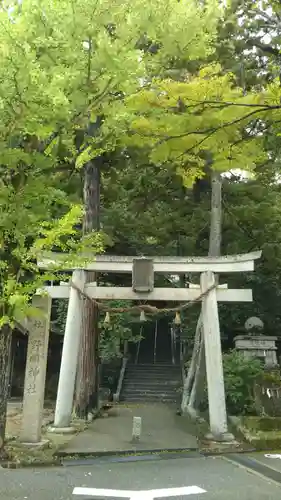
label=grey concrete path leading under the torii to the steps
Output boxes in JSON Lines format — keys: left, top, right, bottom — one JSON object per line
{"left": 58, "top": 403, "right": 197, "bottom": 455}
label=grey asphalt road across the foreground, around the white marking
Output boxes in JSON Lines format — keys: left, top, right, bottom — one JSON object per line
{"left": 0, "top": 457, "right": 281, "bottom": 500}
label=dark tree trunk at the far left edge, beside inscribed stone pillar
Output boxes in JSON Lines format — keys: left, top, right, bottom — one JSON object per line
{"left": 0, "top": 325, "right": 12, "bottom": 457}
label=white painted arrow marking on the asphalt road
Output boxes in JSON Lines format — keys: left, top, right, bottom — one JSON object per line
{"left": 72, "top": 486, "right": 206, "bottom": 500}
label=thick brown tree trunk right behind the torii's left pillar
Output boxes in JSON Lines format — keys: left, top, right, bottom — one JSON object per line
{"left": 75, "top": 158, "right": 101, "bottom": 418}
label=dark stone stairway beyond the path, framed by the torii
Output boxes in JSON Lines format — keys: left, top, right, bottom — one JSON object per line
{"left": 120, "top": 363, "right": 182, "bottom": 403}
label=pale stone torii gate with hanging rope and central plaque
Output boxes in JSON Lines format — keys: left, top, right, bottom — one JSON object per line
{"left": 19, "top": 251, "right": 261, "bottom": 441}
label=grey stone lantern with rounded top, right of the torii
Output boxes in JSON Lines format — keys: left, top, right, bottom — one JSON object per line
{"left": 234, "top": 316, "right": 278, "bottom": 369}
